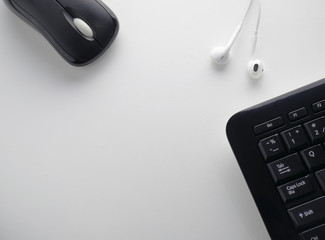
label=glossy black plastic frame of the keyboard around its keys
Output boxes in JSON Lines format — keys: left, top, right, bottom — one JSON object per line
{"left": 226, "top": 79, "right": 325, "bottom": 240}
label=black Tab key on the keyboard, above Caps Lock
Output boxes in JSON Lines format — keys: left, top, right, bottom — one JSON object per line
{"left": 268, "top": 153, "right": 306, "bottom": 184}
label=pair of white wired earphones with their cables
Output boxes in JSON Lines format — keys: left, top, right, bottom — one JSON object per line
{"left": 211, "top": 0, "right": 264, "bottom": 79}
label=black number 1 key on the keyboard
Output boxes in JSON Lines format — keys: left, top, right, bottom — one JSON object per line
{"left": 281, "top": 126, "right": 308, "bottom": 151}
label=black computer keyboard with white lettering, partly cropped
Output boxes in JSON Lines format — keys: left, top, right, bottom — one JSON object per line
{"left": 227, "top": 79, "right": 325, "bottom": 240}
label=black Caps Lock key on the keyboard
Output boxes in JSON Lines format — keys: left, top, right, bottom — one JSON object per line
{"left": 278, "top": 175, "right": 315, "bottom": 203}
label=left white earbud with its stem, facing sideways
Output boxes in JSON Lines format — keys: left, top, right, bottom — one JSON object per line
{"left": 211, "top": 25, "right": 242, "bottom": 65}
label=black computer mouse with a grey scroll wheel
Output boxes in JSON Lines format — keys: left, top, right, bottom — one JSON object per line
{"left": 4, "top": 0, "right": 119, "bottom": 66}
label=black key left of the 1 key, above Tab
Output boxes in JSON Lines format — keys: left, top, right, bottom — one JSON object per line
{"left": 258, "top": 134, "right": 285, "bottom": 160}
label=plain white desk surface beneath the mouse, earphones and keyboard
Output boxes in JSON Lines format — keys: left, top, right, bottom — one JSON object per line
{"left": 0, "top": 0, "right": 325, "bottom": 240}
